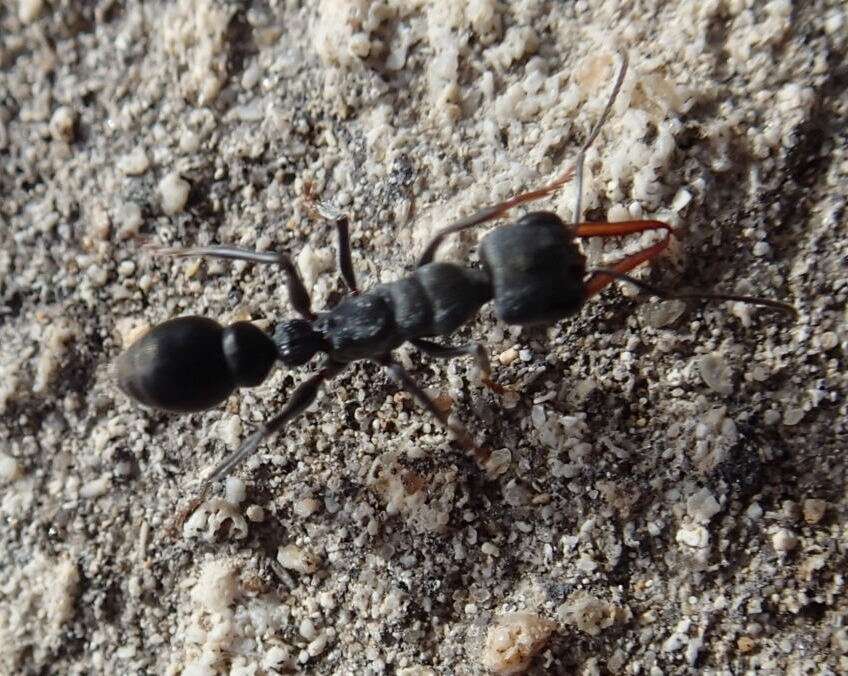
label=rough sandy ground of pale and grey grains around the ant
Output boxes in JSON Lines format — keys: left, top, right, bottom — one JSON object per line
{"left": 0, "top": 0, "right": 848, "bottom": 676}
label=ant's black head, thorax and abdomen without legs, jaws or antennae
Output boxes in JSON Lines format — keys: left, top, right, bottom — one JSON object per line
{"left": 117, "top": 212, "right": 585, "bottom": 412}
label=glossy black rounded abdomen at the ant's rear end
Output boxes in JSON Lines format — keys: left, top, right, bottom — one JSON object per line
{"left": 116, "top": 317, "right": 277, "bottom": 413}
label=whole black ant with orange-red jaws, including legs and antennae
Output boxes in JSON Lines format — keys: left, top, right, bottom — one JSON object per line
{"left": 117, "top": 55, "right": 795, "bottom": 494}
